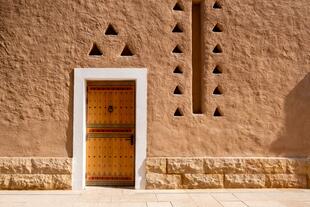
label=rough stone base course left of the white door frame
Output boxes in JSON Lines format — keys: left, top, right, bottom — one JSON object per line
{"left": 0, "top": 157, "right": 72, "bottom": 190}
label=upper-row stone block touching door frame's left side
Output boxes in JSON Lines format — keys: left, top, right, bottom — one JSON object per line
{"left": 31, "top": 157, "right": 72, "bottom": 174}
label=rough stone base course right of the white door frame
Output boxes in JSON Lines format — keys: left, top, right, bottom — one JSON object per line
{"left": 146, "top": 157, "right": 310, "bottom": 189}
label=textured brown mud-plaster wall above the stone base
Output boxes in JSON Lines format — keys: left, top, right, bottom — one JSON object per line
{"left": 0, "top": 0, "right": 310, "bottom": 157}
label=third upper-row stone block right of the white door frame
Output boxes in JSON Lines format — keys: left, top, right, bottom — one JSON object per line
{"left": 204, "top": 158, "right": 245, "bottom": 174}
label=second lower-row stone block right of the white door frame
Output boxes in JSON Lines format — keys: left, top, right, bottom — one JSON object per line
{"left": 183, "top": 174, "right": 224, "bottom": 188}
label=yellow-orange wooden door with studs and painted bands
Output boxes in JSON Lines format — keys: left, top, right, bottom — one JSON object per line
{"left": 86, "top": 81, "right": 135, "bottom": 185}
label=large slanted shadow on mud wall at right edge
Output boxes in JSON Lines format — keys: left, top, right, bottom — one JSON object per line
{"left": 270, "top": 73, "right": 310, "bottom": 156}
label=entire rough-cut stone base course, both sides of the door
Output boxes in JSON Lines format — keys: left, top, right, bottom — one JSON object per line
{"left": 0, "top": 157, "right": 310, "bottom": 190}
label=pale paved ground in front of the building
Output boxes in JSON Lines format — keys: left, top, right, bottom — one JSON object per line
{"left": 0, "top": 187, "right": 310, "bottom": 207}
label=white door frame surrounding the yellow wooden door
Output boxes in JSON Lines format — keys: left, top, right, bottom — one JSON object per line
{"left": 72, "top": 68, "right": 147, "bottom": 190}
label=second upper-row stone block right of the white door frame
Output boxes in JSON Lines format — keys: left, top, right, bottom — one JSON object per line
{"left": 167, "top": 158, "right": 204, "bottom": 174}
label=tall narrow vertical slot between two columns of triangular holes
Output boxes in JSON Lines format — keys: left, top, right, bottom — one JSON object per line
{"left": 192, "top": 1, "right": 202, "bottom": 114}
